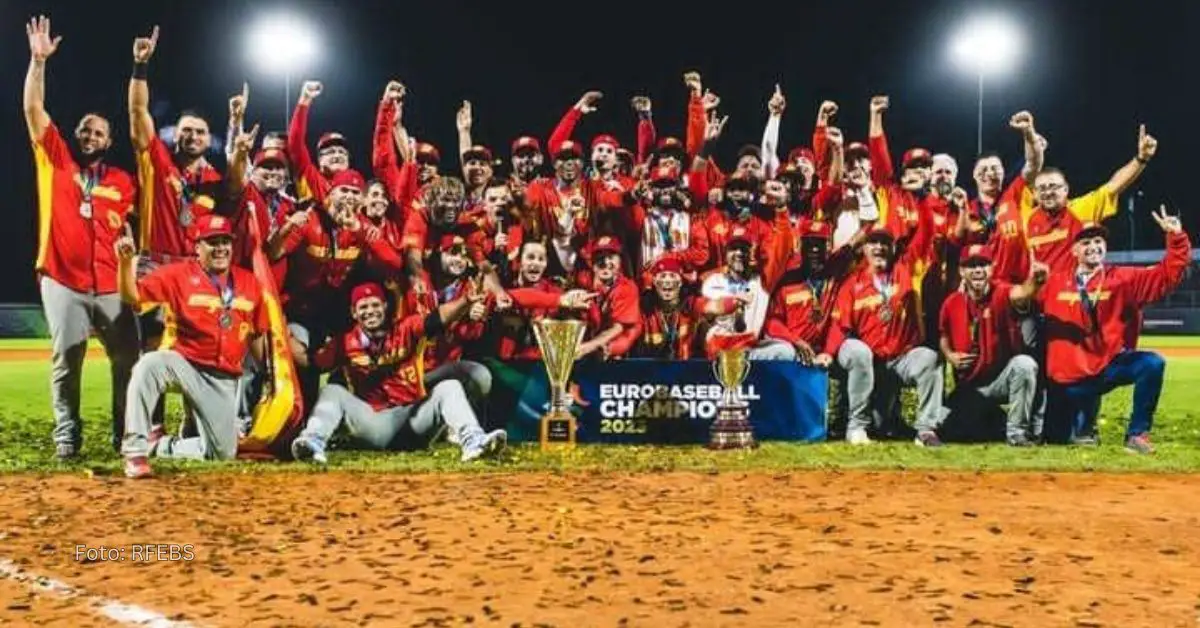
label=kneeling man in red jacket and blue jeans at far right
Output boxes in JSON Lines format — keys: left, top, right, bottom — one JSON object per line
{"left": 1038, "top": 207, "right": 1192, "bottom": 454}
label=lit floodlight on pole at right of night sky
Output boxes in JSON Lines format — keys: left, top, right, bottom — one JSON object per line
{"left": 950, "top": 14, "right": 1021, "bottom": 155}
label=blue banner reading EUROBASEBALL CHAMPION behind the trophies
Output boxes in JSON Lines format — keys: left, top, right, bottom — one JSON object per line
{"left": 487, "top": 360, "right": 828, "bottom": 444}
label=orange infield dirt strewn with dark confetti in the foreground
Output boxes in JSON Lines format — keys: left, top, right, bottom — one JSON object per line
{"left": 0, "top": 472, "right": 1200, "bottom": 627}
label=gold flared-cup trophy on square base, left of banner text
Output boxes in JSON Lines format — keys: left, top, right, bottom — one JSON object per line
{"left": 533, "top": 318, "right": 587, "bottom": 451}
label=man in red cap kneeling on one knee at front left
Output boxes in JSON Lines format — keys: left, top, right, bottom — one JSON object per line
{"left": 115, "top": 214, "right": 268, "bottom": 479}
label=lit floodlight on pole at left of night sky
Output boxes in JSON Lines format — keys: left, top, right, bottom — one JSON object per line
{"left": 246, "top": 13, "right": 318, "bottom": 128}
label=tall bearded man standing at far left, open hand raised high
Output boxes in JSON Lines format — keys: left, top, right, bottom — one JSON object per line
{"left": 24, "top": 17, "right": 138, "bottom": 459}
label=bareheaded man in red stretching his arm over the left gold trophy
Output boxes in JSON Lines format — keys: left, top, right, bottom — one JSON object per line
{"left": 491, "top": 240, "right": 596, "bottom": 360}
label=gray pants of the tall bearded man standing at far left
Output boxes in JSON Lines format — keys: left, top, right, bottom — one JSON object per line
{"left": 38, "top": 276, "right": 138, "bottom": 447}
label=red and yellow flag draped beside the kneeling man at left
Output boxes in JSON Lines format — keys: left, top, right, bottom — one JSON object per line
{"left": 238, "top": 203, "right": 304, "bottom": 459}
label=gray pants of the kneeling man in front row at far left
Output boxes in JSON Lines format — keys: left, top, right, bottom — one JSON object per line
{"left": 121, "top": 349, "right": 238, "bottom": 460}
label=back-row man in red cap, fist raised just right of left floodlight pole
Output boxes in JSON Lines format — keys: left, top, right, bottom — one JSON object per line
{"left": 288, "top": 80, "right": 350, "bottom": 205}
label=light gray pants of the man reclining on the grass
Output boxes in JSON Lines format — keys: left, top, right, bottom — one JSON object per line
{"left": 300, "top": 379, "right": 482, "bottom": 449}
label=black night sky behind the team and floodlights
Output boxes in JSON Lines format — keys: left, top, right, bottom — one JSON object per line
{"left": 0, "top": 0, "right": 1200, "bottom": 303}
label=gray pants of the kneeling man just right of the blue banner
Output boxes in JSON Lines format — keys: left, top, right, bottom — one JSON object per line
{"left": 838, "top": 339, "right": 947, "bottom": 431}
